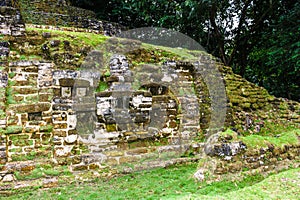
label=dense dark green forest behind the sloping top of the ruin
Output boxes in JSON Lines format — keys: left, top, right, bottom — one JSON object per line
{"left": 71, "top": 0, "right": 300, "bottom": 101}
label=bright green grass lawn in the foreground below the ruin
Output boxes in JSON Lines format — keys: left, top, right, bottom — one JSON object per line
{"left": 2, "top": 163, "right": 300, "bottom": 199}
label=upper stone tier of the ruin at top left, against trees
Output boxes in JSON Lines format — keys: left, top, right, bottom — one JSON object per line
{"left": 19, "top": 0, "right": 124, "bottom": 36}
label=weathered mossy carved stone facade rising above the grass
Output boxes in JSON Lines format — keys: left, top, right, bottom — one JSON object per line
{"left": 0, "top": 56, "right": 204, "bottom": 179}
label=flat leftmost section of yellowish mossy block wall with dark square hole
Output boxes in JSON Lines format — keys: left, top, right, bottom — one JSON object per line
{"left": 5, "top": 61, "right": 53, "bottom": 161}
